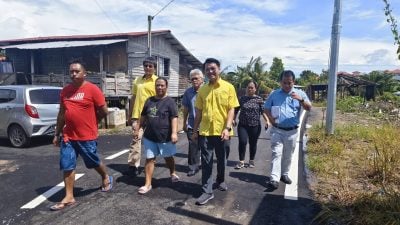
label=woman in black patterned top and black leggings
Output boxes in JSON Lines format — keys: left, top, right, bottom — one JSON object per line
{"left": 235, "top": 81, "right": 268, "bottom": 169}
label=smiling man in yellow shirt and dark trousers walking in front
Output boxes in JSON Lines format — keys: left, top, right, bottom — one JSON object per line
{"left": 192, "top": 58, "right": 239, "bottom": 205}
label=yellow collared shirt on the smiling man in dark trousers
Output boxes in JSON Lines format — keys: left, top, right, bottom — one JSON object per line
{"left": 195, "top": 78, "right": 239, "bottom": 136}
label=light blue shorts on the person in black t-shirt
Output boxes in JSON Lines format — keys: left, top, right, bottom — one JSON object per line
{"left": 142, "top": 138, "right": 176, "bottom": 159}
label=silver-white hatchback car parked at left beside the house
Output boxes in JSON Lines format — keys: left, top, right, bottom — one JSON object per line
{"left": 0, "top": 85, "right": 62, "bottom": 148}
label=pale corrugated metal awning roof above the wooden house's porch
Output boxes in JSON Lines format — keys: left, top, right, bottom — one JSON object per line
{"left": 0, "top": 39, "right": 127, "bottom": 49}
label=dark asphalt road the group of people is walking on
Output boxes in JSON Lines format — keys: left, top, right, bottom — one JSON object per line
{"left": 0, "top": 115, "right": 318, "bottom": 225}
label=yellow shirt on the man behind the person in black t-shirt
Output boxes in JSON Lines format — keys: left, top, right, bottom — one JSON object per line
{"left": 132, "top": 74, "right": 158, "bottom": 119}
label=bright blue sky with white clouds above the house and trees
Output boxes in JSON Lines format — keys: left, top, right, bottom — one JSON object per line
{"left": 0, "top": 0, "right": 400, "bottom": 74}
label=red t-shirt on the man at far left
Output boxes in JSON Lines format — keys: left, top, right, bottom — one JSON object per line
{"left": 61, "top": 81, "right": 106, "bottom": 141}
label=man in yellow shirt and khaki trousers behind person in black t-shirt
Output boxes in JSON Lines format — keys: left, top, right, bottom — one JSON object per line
{"left": 128, "top": 57, "right": 158, "bottom": 176}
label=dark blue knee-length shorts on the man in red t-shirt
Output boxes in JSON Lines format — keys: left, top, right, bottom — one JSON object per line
{"left": 60, "top": 140, "right": 100, "bottom": 171}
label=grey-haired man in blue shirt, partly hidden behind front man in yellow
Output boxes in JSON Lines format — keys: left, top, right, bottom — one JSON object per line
{"left": 182, "top": 69, "right": 204, "bottom": 177}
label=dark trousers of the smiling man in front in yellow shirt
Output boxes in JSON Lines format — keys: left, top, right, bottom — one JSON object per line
{"left": 199, "top": 136, "right": 230, "bottom": 194}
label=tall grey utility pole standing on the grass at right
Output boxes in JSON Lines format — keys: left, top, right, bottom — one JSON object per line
{"left": 326, "top": 0, "right": 342, "bottom": 134}
